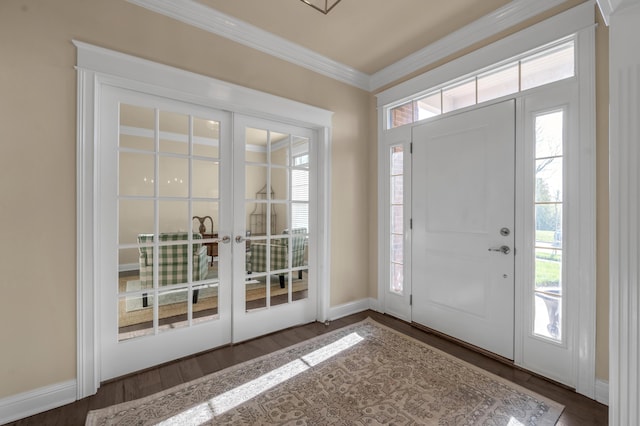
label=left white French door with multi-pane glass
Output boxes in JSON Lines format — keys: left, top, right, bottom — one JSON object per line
{"left": 97, "top": 87, "right": 232, "bottom": 380}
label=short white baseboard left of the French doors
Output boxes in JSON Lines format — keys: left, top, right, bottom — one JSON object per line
{"left": 0, "top": 379, "right": 77, "bottom": 425}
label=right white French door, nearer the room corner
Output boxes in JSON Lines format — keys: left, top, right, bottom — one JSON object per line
{"left": 233, "top": 115, "right": 317, "bottom": 341}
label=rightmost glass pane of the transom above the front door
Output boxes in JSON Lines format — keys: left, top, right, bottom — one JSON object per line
{"left": 521, "top": 41, "right": 575, "bottom": 90}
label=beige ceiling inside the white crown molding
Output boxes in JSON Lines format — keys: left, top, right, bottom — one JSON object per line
{"left": 198, "top": 0, "right": 510, "bottom": 74}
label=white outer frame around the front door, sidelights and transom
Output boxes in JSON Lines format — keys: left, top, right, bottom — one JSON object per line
{"left": 377, "top": 2, "right": 596, "bottom": 398}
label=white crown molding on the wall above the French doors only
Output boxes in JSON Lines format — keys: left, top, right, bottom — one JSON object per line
{"left": 128, "top": 0, "right": 369, "bottom": 91}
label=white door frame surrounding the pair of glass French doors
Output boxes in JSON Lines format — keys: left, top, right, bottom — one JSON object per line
{"left": 73, "top": 41, "right": 333, "bottom": 399}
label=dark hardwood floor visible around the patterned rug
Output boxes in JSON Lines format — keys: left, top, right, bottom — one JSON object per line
{"left": 10, "top": 311, "right": 608, "bottom": 426}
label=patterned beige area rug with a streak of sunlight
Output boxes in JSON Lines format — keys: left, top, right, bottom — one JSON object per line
{"left": 86, "top": 319, "right": 563, "bottom": 426}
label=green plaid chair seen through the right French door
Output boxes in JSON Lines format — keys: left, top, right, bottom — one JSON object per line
{"left": 246, "top": 228, "right": 307, "bottom": 288}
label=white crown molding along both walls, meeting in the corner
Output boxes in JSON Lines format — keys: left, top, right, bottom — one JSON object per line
{"left": 127, "top": 0, "right": 568, "bottom": 91}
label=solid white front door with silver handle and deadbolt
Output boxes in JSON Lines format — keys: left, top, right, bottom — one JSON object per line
{"left": 412, "top": 101, "right": 515, "bottom": 359}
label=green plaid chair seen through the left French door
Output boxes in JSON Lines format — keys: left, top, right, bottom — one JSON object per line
{"left": 138, "top": 232, "right": 209, "bottom": 306}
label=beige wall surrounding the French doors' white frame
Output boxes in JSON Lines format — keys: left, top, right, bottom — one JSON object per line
{"left": 0, "top": 0, "right": 375, "bottom": 398}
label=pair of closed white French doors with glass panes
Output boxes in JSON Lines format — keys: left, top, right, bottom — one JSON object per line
{"left": 96, "top": 87, "right": 316, "bottom": 380}
